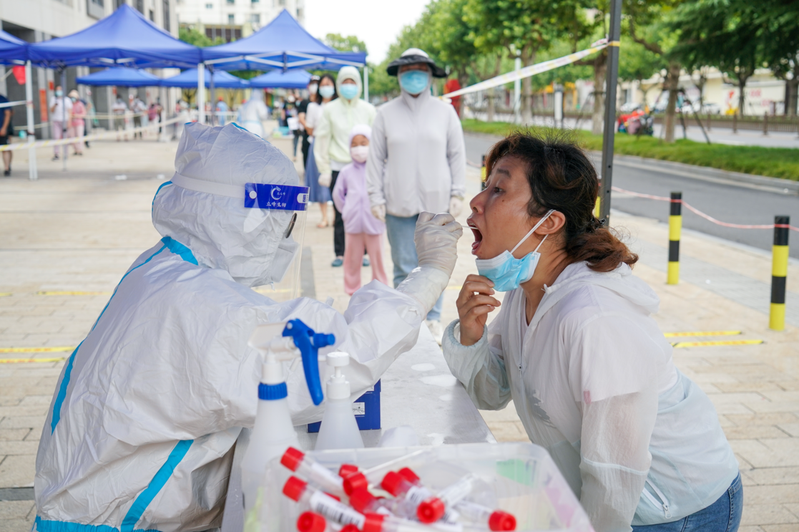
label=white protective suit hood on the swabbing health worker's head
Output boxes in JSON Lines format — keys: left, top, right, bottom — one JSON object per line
{"left": 152, "top": 123, "right": 299, "bottom": 286}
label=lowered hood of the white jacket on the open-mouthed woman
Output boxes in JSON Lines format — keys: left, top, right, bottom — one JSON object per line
{"left": 536, "top": 262, "right": 660, "bottom": 327}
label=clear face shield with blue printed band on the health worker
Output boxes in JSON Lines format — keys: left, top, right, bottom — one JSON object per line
{"left": 167, "top": 174, "right": 308, "bottom": 302}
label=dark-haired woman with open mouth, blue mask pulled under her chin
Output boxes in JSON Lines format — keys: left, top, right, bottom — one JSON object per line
{"left": 443, "top": 133, "right": 743, "bottom": 532}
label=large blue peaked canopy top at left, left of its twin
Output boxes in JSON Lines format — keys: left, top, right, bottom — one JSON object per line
{"left": 28, "top": 4, "right": 202, "bottom": 69}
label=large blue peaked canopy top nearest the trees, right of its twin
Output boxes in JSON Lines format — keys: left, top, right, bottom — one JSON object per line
{"left": 203, "top": 9, "right": 366, "bottom": 81}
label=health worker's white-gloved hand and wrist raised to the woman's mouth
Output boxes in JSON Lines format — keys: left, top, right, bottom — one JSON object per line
{"left": 397, "top": 212, "right": 463, "bottom": 316}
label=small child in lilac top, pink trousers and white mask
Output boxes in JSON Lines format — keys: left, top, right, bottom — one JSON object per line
{"left": 333, "top": 124, "right": 388, "bottom": 295}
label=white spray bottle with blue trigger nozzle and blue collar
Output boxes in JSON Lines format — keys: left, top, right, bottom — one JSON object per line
{"left": 241, "top": 320, "right": 336, "bottom": 512}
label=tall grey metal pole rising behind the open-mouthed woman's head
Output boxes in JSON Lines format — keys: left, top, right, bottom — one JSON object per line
{"left": 599, "top": 0, "right": 621, "bottom": 227}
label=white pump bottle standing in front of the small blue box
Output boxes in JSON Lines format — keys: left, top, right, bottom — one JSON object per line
{"left": 316, "top": 352, "right": 363, "bottom": 451}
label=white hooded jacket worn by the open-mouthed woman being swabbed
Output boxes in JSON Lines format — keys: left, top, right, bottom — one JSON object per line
{"left": 443, "top": 263, "right": 738, "bottom": 532}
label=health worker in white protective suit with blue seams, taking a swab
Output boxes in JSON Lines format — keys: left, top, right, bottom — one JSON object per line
{"left": 34, "top": 124, "right": 462, "bottom": 532}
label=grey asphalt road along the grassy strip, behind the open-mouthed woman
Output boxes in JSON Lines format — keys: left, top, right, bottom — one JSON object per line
{"left": 465, "top": 134, "right": 799, "bottom": 259}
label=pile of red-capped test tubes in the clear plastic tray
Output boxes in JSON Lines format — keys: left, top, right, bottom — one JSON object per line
{"left": 280, "top": 447, "right": 516, "bottom": 532}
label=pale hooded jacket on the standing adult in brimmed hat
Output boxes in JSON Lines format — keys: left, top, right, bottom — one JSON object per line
{"left": 366, "top": 71, "right": 466, "bottom": 217}
